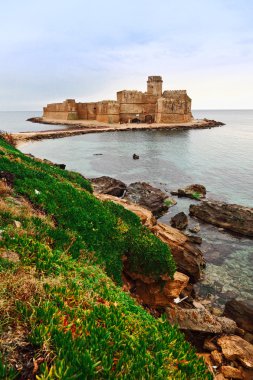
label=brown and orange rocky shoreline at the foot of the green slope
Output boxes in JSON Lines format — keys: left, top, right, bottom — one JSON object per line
{"left": 91, "top": 177, "right": 253, "bottom": 380}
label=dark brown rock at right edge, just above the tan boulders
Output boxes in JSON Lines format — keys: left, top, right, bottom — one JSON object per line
{"left": 224, "top": 299, "right": 253, "bottom": 333}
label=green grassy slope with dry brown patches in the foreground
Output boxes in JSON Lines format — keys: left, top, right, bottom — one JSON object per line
{"left": 0, "top": 140, "right": 212, "bottom": 380}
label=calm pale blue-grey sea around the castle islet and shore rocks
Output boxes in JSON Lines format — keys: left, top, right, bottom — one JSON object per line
{"left": 0, "top": 110, "right": 253, "bottom": 308}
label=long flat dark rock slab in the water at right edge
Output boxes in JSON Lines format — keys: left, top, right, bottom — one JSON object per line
{"left": 190, "top": 201, "right": 253, "bottom": 236}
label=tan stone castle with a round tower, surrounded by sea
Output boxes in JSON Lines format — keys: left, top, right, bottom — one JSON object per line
{"left": 43, "top": 76, "right": 192, "bottom": 123}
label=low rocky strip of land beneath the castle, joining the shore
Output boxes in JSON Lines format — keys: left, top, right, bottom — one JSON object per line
{"left": 12, "top": 117, "right": 224, "bottom": 144}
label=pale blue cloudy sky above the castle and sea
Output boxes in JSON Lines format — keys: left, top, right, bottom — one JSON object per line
{"left": 0, "top": 0, "right": 253, "bottom": 111}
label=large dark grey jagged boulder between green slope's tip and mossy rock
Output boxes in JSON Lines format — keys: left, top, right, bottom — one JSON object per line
{"left": 125, "top": 182, "right": 176, "bottom": 217}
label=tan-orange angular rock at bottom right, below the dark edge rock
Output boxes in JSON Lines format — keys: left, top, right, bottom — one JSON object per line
{"left": 217, "top": 335, "right": 253, "bottom": 368}
